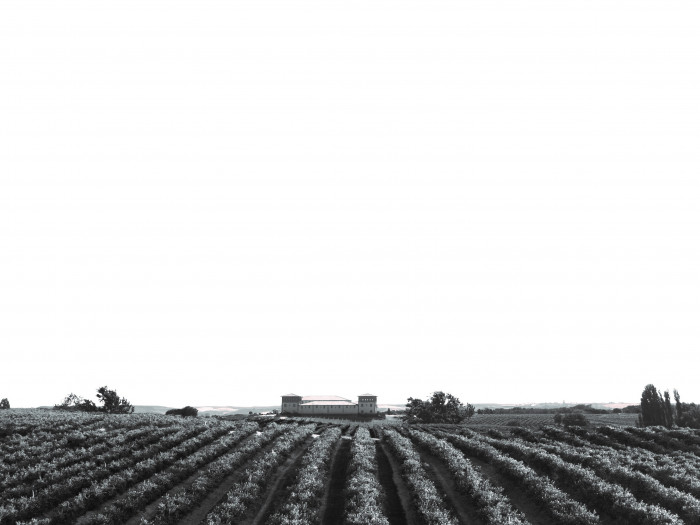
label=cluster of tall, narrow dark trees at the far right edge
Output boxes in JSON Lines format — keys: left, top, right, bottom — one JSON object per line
{"left": 639, "top": 384, "right": 700, "bottom": 428}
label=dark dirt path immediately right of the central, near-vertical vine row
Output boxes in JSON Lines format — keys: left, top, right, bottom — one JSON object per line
{"left": 377, "top": 440, "right": 420, "bottom": 525}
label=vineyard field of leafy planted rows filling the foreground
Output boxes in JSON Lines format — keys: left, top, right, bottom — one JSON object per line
{"left": 0, "top": 410, "right": 700, "bottom": 525}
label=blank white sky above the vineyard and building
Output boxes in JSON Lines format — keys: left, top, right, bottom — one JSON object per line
{"left": 0, "top": 0, "right": 700, "bottom": 406}
